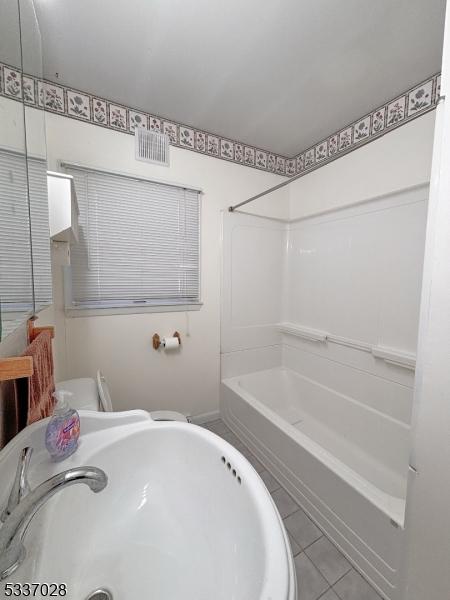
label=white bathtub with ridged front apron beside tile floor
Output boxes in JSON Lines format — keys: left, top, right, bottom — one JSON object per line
{"left": 221, "top": 367, "right": 409, "bottom": 600}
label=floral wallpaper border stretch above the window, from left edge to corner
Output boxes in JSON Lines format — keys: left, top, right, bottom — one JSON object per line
{"left": 0, "top": 63, "right": 287, "bottom": 175}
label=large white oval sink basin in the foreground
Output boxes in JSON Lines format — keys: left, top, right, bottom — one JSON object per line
{"left": 0, "top": 411, "right": 296, "bottom": 600}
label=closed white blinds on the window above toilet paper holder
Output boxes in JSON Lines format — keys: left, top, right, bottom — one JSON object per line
{"left": 66, "top": 165, "right": 200, "bottom": 308}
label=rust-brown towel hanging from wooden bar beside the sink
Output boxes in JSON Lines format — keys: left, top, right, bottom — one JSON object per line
{"left": 23, "top": 331, "right": 55, "bottom": 425}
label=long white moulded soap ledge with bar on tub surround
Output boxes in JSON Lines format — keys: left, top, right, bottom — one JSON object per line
{"left": 278, "top": 322, "right": 416, "bottom": 370}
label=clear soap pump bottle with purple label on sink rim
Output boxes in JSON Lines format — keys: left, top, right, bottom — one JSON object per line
{"left": 45, "top": 390, "right": 80, "bottom": 461}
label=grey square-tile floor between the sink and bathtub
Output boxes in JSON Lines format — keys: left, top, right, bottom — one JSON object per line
{"left": 204, "top": 420, "right": 381, "bottom": 600}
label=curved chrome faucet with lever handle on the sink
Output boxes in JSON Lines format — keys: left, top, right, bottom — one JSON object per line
{"left": 0, "top": 448, "right": 108, "bottom": 581}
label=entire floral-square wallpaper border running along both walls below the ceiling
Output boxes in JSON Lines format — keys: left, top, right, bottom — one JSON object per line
{"left": 0, "top": 63, "right": 441, "bottom": 177}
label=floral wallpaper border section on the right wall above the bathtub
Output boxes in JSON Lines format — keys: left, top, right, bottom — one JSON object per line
{"left": 286, "top": 73, "right": 441, "bottom": 177}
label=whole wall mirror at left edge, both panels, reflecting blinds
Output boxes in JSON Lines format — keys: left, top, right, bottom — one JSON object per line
{"left": 0, "top": 0, "right": 51, "bottom": 341}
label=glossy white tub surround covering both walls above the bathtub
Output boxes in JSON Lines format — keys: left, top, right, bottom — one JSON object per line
{"left": 222, "top": 186, "right": 428, "bottom": 424}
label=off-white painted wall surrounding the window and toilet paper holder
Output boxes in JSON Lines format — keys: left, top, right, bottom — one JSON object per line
{"left": 42, "top": 114, "right": 288, "bottom": 415}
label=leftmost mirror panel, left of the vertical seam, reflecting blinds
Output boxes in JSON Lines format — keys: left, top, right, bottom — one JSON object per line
{"left": 0, "top": 2, "right": 33, "bottom": 340}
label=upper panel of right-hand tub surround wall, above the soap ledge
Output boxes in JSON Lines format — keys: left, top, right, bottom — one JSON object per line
{"left": 283, "top": 186, "right": 428, "bottom": 353}
